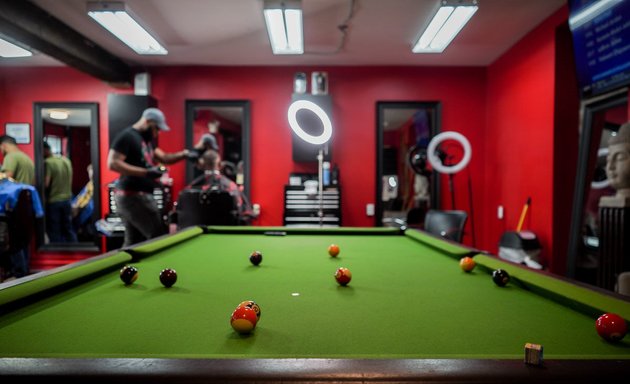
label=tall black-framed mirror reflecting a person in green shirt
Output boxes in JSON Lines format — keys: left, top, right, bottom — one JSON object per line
{"left": 34, "top": 103, "right": 101, "bottom": 252}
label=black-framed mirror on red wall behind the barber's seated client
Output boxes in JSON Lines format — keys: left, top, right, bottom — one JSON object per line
{"left": 186, "top": 100, "right": 250, "bottom": 199}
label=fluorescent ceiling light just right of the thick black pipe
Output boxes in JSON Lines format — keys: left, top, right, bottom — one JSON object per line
{"left": 88, "top": 2, "right": 168, "bottom": 55}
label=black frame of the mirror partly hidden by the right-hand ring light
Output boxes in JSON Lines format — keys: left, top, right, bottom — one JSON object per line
{"left": 374, "top": 101, "right": 442, "bottom": 227}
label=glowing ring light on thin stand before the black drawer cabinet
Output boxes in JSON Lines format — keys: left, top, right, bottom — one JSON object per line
{"left": 287, "top": 100, "right": 332, "bottom": 227}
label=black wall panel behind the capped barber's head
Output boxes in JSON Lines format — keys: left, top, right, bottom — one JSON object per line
{"left": 107, "top": 93, "right": 157, "bottom": 146}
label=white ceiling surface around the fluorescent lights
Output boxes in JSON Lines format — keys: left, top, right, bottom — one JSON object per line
{"left": 0, "top": 0, "right": 566, "bottom": 66}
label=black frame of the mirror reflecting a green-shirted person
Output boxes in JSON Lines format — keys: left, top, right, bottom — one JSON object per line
{"left": 33, "top": 102, "right": 101, "bottom": 252}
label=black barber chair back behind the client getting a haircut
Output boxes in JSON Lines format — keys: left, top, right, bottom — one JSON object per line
{"left": 176, "top": 189, "right": 238, "bottom": 228}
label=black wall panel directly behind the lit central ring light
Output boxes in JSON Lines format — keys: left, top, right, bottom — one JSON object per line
{"left": 291, "top": 94, "right": 336, "bottom": 163}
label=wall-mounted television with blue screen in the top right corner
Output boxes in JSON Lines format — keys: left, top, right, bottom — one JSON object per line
{"left": 569, "top": 0, "right": 630, "bottom": 98}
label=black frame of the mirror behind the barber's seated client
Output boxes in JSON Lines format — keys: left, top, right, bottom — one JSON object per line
{"left": 186, "top": 99, "right": 251, "bottom": 200}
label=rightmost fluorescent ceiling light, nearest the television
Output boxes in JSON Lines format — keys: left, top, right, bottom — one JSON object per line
{"left": 412, "top": 1, "right": 479, "bottom": 53}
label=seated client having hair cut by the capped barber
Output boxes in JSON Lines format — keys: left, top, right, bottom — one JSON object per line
{"left": 186, "top": 149, "right": 254, "bottom": 224}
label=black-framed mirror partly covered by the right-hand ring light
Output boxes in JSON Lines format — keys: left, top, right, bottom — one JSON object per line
{"left": 375, "top": 102, "right": 440, "bottom": 226}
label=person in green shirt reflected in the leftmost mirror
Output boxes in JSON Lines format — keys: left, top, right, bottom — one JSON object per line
{"left": 44, "top": 142, "right": 77, "bottom": 243}
